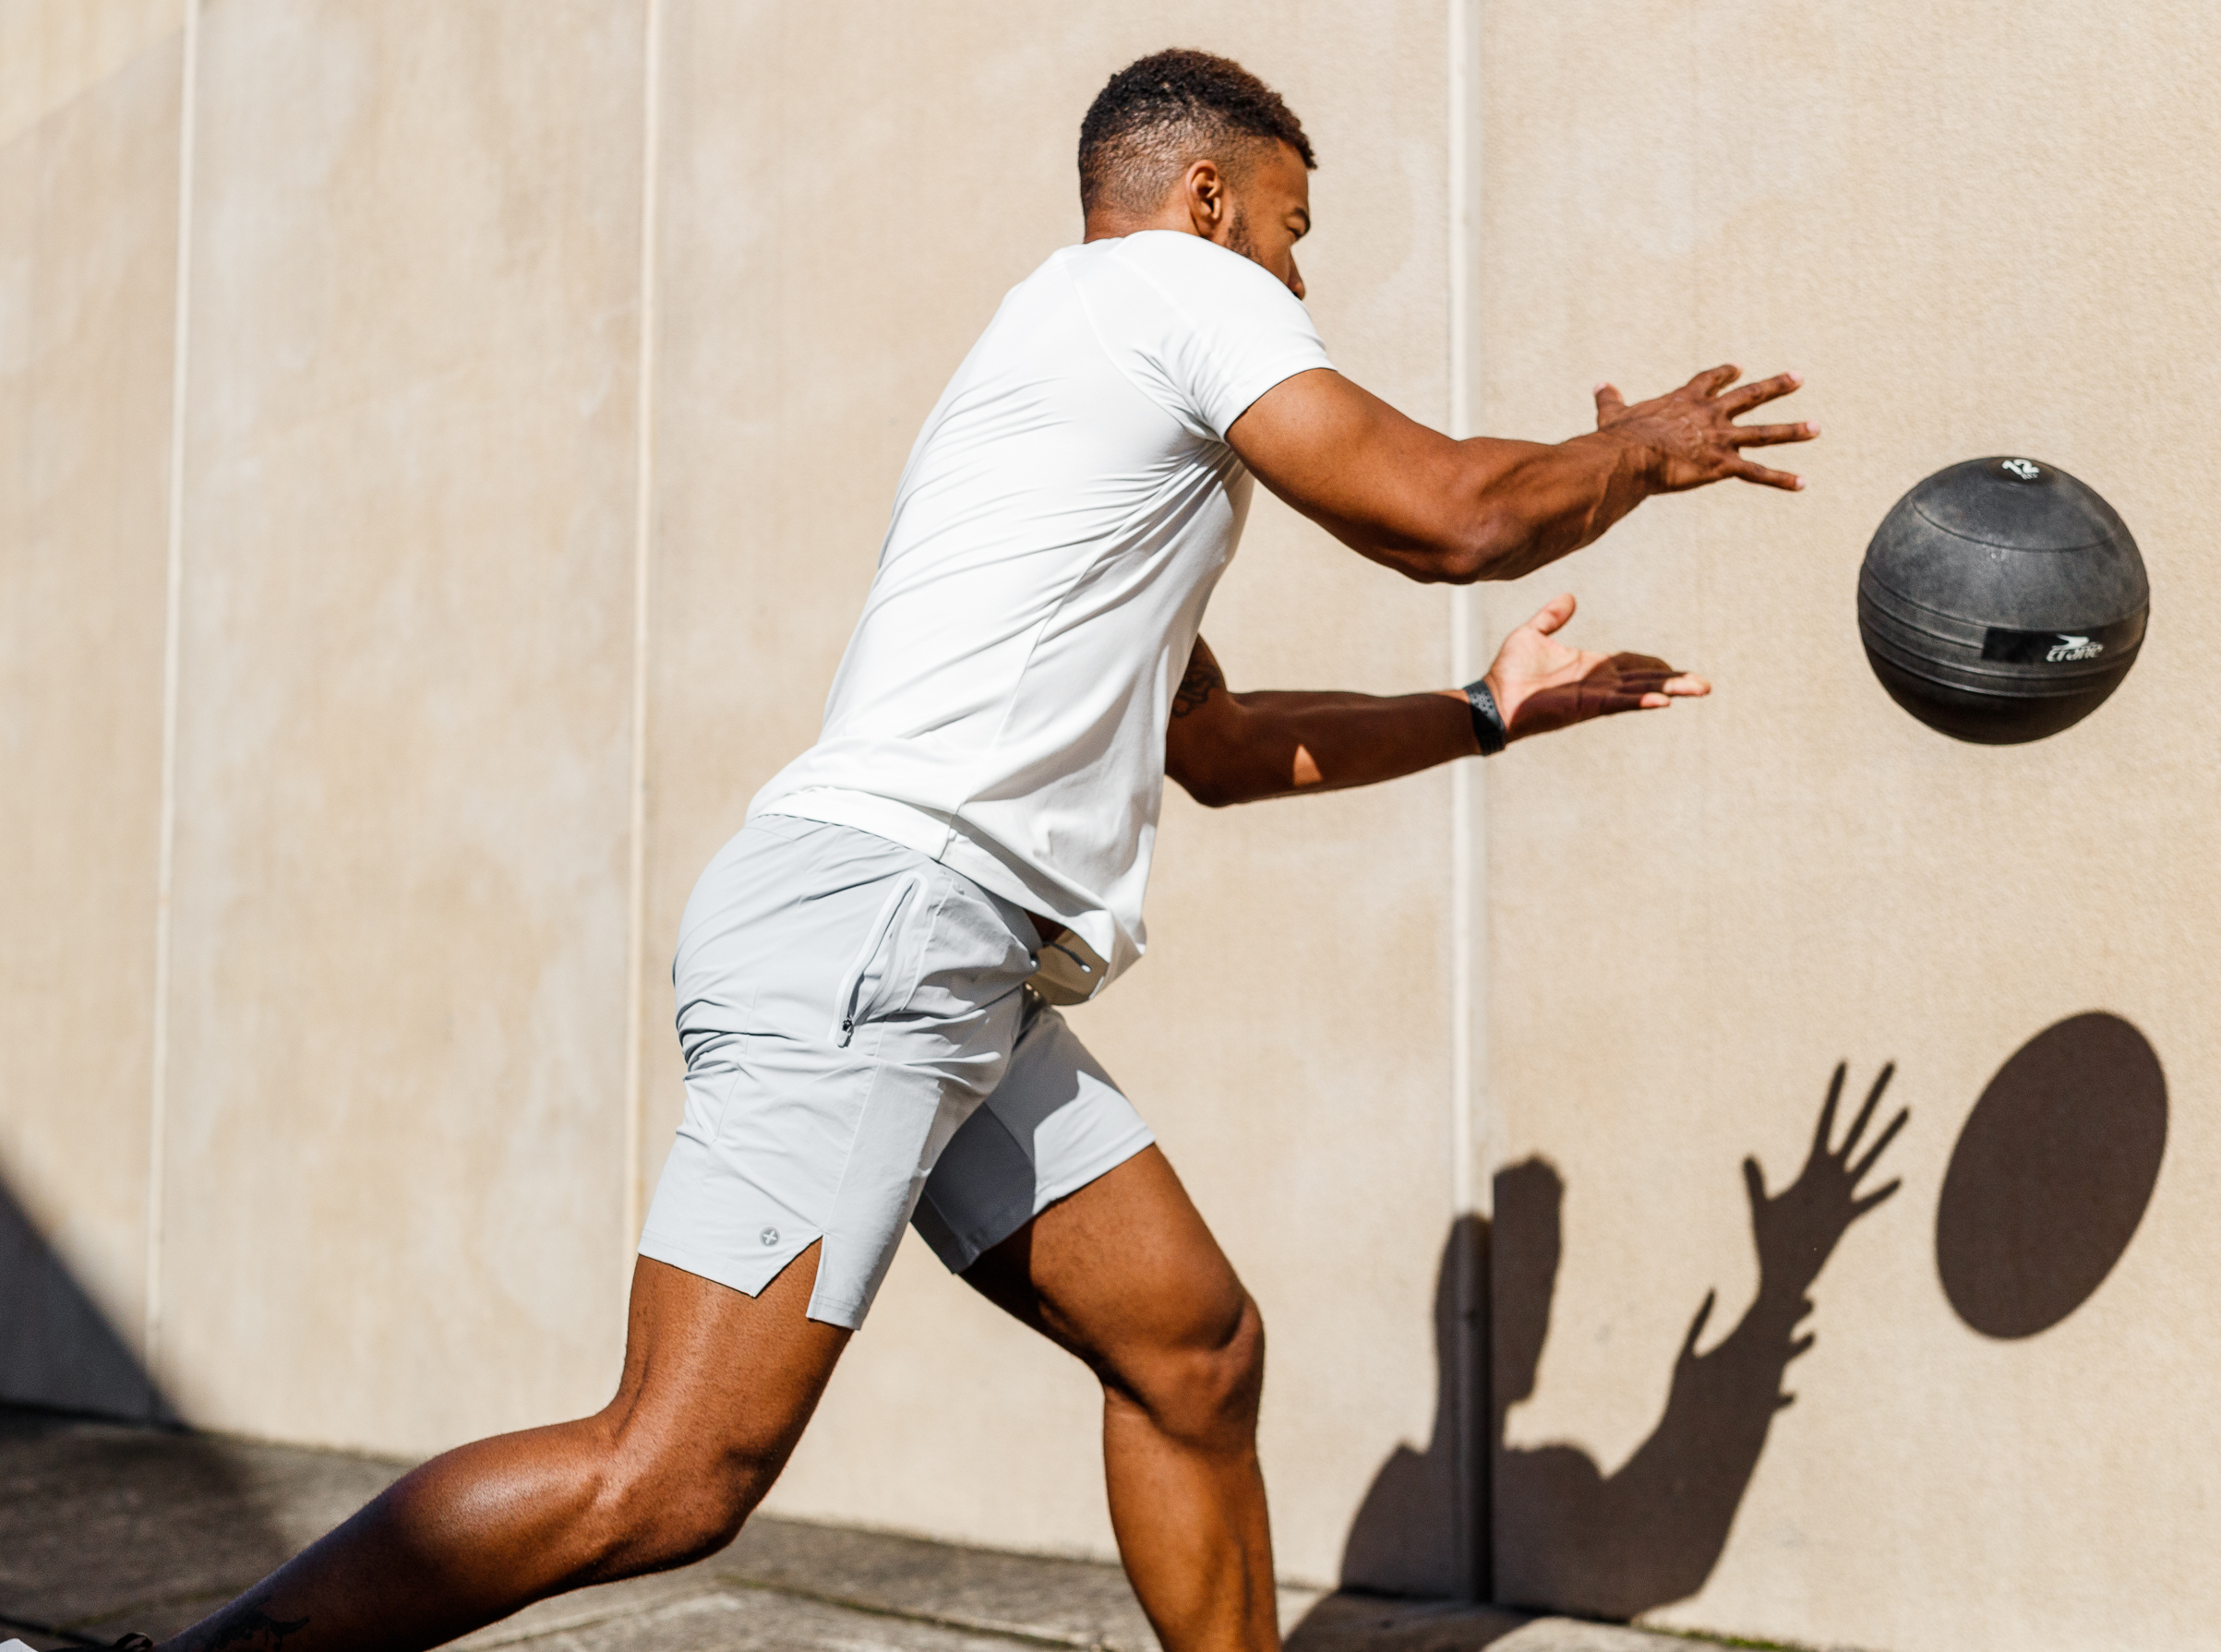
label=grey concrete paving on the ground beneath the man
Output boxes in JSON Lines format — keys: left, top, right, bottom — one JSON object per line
{"left": 0, "top": 1407, "right": 1690, "bottom": 1652}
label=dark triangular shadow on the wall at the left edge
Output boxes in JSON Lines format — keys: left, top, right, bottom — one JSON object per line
{"left": 0, "top": 1183, "right": 171, "bottom": 1421}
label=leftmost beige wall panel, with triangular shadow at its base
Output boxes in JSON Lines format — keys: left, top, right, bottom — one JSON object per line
{"left": 0, "top": 0, "right": 180, "bottom": 1415}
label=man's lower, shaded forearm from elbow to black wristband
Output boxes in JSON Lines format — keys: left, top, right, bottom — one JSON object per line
{"left": 1175, "top": 688, "right": 1479, "bottom": 808}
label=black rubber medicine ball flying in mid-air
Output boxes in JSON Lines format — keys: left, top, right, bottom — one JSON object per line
{"left": 1859, "top": 448, "right": 2152, "bottom": 746}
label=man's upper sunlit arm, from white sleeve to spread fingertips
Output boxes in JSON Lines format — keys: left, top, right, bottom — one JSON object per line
{"left": 1226, "top": 366, "right": 1817, "bottom": 584}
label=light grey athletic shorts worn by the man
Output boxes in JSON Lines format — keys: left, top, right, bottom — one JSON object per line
{"left": 640, "top": 815, "right": 1153, "bottom": 1328}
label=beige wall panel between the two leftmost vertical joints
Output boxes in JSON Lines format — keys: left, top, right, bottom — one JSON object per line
{"left": 158, "top": 0, "right": 642, "bottom": 1450}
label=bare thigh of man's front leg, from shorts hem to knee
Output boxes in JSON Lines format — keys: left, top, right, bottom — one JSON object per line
{"left": 964, "top": 1145, "right": 1251, "bottom": 1393}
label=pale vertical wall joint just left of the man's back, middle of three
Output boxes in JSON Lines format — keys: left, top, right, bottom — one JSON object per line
{"left": 619, "top": 0, "right": 664, "bottom": 1290}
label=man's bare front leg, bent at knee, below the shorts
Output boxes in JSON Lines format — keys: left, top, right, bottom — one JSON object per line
{"left": 964, "top": 1148, "right": 1279, "bottom": 1652}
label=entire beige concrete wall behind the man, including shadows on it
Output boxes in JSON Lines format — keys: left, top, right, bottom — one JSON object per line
{"left": 0, "top": 0, "right": 2221, "bottom": 1652}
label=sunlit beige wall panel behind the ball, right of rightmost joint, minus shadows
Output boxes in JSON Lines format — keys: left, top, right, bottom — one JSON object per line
{"left": 1482, "top": 2, "right": 2221, "bottom": 1652}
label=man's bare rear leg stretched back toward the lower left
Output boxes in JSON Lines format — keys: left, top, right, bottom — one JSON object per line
{"left": 162, "top": 1246, "right": 850, "bottom": 1652}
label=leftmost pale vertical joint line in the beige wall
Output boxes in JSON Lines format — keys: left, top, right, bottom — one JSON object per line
{"left": 140, "top": 0, "right": 200, "bottom": 1393}
